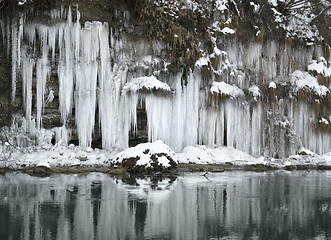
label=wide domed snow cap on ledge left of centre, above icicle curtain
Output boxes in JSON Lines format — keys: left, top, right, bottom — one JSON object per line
{"left": 123, "top": 76, "right": 171, "bottom": 93}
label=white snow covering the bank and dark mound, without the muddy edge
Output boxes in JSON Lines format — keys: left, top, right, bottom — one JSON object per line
{"left": 0, "top": 140, "right": 331, "bottom": 172}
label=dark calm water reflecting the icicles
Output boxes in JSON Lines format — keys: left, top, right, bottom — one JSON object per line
{"left": 0, "top": 172, "right": 331, "bottom": 240}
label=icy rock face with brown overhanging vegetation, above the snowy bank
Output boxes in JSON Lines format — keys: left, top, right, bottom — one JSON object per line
{"left": 0, "top": 0, "right": 331, "bottom": 158}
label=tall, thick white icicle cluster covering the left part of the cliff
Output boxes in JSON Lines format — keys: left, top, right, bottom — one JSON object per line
{"left": 5, "top": 8, "right": 134, "bottom": 147}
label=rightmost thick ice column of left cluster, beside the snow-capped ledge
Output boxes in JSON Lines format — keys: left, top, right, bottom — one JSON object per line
{"left": 98, "top": 24, "right": 134, "bottom": 148}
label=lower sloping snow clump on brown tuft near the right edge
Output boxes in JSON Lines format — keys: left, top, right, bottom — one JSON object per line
{"left": 291, "top": 70, "right": 330, "bottom": 97}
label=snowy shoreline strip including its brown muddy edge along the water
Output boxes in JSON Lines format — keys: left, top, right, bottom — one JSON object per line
{"left": 0, "top": 140, "right": 331, "bottom": 174}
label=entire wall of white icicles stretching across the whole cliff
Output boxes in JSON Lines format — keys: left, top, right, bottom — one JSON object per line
{"left": 1, "top": 5, "right": 331, "bottom": 157}
